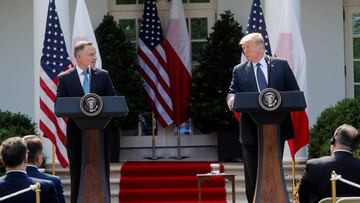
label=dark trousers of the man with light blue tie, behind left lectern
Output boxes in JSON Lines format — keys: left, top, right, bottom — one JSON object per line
{"left": 66, "top": 122, "right": 110, "bottom": 203}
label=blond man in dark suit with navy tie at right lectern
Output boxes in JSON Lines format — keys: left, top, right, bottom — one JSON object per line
{"left": 226, "top": 33, "right": 299, "bottom": 202}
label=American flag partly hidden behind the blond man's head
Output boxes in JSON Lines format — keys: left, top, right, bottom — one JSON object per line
{"left": 246, "top": 0, "right": 272, "bottom": 56}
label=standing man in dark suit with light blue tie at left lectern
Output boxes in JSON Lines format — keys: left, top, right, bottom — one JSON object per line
{"left": 57, "top": 41, "right": 116, "bottom": 203}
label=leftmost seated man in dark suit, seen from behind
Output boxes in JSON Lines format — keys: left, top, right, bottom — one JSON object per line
{"left": 0, "top": 137, "right": 59, "bottom": 203}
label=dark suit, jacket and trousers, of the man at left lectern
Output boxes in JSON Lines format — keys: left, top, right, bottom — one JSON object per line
{"left": 57, "top": 68, "right": 116, "bottom": 202}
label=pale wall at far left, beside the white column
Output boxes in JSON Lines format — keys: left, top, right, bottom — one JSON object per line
{"left": 0, "top": 0, "right": 34, "bottom": 117}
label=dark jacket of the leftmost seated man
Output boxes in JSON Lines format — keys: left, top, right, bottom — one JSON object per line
{"left": 0, "top": 171, "right": 59, "bottom": 203}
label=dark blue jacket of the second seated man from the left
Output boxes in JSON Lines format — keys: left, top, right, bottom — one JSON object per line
{"left": 26, "top": 166, "right": 65, "bottom": 203}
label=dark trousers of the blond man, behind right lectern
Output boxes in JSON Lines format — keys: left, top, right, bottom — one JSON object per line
{"left": 242, "top": 141, "right": 285, "bottom": 202}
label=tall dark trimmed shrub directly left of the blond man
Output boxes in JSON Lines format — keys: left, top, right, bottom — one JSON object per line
{"left": 190, "top": 11, "right": 244, "bottom": 132}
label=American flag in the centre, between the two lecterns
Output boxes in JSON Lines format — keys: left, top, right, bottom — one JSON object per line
{"left": 137, "top": 0, "right": 173, "bottom": 127}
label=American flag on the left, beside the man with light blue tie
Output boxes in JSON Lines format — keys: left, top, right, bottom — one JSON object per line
{"left": 39, "top": 0, "right": 71, "bottom": 167}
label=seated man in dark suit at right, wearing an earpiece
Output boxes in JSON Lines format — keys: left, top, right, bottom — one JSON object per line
{"left": 299, "top": 124, "right": 360, "bottom": 203}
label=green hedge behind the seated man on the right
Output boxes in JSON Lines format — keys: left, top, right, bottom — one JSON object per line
{"left": 309, "top": 99, "right": 360, "bottom": 158}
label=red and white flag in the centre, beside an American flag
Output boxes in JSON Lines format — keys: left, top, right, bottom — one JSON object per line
{"left": 166, "top": 0, "right": 191, "bottom": 126}
